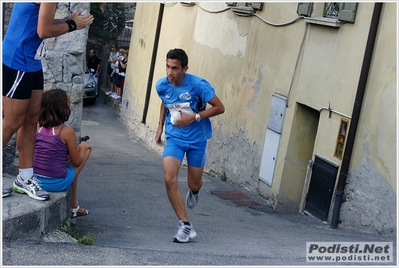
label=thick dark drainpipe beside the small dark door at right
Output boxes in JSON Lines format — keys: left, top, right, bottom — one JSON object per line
{"left": 331, "top": 3, "right": 382, "bottom": 229}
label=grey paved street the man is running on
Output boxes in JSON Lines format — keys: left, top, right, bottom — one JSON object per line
{"left": 3, "top": 94, "right": 396, "bottom": 266}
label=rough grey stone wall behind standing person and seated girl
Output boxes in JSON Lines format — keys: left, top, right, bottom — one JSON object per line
{"left": 3, "top": 2, "right": 90, "bottom": 174}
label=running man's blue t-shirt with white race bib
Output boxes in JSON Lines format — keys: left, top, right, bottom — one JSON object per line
{"left": 155, "top": 73, "right": 215, "bottom": 143}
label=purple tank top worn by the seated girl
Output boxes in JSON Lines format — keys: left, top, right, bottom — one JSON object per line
{"left": 33, "top": 125, "right": 68, "bottom": 178}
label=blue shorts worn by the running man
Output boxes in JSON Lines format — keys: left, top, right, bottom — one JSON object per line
{"left": 162, "top": 138, "right": 207, "bottom": 168}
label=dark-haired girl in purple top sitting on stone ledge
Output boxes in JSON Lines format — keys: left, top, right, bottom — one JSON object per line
{"left": 33, "top": 89, "right": 91, "bottom": 218}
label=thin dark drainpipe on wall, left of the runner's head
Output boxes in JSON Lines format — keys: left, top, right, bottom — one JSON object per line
{"left": 141, "top": 3, "right": 165, "bottom": 124}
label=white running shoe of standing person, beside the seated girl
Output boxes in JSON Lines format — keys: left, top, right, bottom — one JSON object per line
{"left": 12, "top": 175, "right": 50, "bottom": 201}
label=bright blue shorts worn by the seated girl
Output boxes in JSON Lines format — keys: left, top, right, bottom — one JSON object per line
{"left": 36, "top": 164, "right": 75, "bottom": 192}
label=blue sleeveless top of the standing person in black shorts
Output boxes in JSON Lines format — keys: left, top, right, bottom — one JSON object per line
{"left": 2, "top": 2, "right": 43, "bottom": 72}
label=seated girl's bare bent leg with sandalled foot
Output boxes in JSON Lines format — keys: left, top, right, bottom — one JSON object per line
{"left": 71, "top": 142, "right": 91, "bottom": 217}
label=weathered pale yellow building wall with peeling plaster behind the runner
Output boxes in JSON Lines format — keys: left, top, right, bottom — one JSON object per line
{"left": 120, "top": 2, "right": 396, "bottom": 232}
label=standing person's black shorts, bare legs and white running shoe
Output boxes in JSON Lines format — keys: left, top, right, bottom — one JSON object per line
{"left": 3, "top": 68, "right": 50, "bottom": 200}
